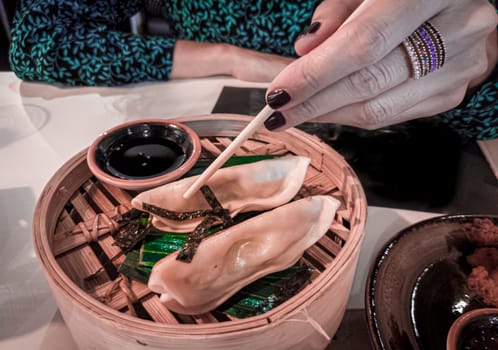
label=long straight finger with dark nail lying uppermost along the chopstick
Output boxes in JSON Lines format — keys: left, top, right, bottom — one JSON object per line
{"left": 268, "top": 0, "right": 451, "bottom": 110}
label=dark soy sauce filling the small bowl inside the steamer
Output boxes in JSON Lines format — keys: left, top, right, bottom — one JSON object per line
{"left": 105, "top": 137, "right": 186, "bottom": 179}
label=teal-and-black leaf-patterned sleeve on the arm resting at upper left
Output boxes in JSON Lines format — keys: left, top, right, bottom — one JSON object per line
{"left": 9, "top": 0, "right": 175, "bottom": 86}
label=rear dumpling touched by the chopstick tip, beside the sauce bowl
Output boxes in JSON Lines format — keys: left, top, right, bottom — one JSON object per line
{"left": 131, "top": 156, "right": 310, "bottom": 232}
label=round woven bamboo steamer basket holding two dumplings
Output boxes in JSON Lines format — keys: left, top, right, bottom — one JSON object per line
{"left": 33, "top": 114, "right": 367, "bottom": 350}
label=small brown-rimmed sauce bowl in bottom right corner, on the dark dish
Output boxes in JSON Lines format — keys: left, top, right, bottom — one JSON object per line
{"left": 446, "top": 308, "right": 498, "bottom": 350}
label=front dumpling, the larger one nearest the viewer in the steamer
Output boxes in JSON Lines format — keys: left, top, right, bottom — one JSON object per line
{"left": 148, "top": 196, "right": 340, "bottom": 314}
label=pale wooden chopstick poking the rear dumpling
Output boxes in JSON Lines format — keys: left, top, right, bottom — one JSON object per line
{"left": 183, "top": 105, "right": 273, "bottom": 199}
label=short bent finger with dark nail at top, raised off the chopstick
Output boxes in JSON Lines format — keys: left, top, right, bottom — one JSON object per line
{"left": 294, "top": 0, "right": 361, "bottom": 56}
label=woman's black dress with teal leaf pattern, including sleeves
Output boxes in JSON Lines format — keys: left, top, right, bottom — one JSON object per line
{"left": 6, "top": 0, "right": 498, "bottom": 139}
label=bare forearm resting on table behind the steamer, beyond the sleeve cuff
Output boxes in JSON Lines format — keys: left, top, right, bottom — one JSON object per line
{"left": 171, "top": 40, "right": 294, "bottom": 82}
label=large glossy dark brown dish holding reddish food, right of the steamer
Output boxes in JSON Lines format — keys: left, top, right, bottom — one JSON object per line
{"left": 365, "top": 215, "right": 498, "bottom": 350}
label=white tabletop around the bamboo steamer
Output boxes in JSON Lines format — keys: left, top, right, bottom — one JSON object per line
{"left": 0, "top": 72, "right": 494, "bottom": 350}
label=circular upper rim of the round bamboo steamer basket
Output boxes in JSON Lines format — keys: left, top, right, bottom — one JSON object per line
{"left": 33, "top": 115, "right": 367, "bottom": 337}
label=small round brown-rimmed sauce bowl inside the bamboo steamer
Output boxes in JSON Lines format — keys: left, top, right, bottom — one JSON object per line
{"left": 87, "top": 119, "right": 201, "bottom": 190}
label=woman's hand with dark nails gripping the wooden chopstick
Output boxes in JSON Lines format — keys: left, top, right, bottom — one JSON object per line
{"left": 265, "top": 0, "right": 497, "bottom": 130}
